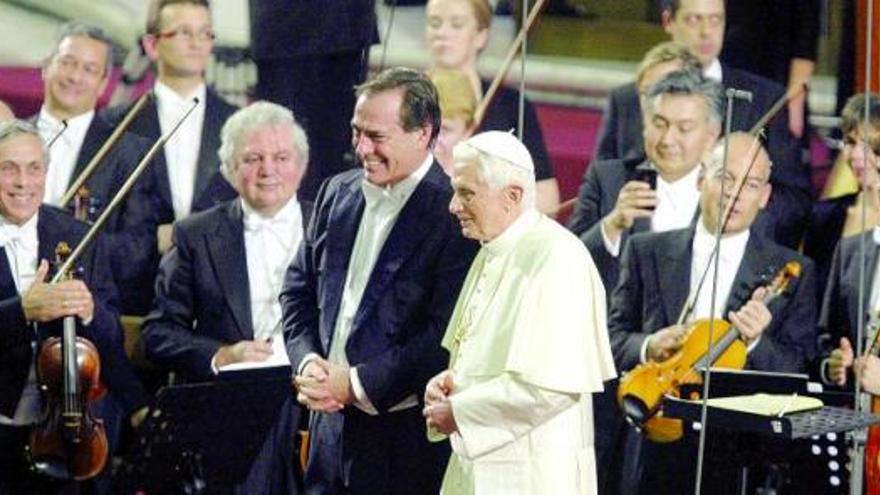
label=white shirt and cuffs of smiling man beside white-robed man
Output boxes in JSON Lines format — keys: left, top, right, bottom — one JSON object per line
{"left": 322, "top": 154, "right": 434, "bottom": 415}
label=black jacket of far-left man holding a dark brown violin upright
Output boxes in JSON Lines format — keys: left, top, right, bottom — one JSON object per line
{"left": 0, "top": 205, "right": 147, "bottom": 417}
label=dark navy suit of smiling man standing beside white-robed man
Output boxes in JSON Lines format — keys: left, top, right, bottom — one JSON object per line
{"left": 281, "top": 162, "right": 477, "bottom": 493}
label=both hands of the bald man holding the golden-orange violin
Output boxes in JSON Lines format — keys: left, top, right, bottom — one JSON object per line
{"left": 646, "top": 287, "right": 773, "bottom": 361}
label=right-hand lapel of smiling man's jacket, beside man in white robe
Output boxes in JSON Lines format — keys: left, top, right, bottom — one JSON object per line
{"left": 352, "top": 163, "right": 445, "bottom": 332}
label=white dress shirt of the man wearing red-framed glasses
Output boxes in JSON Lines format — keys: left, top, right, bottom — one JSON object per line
{"left": 153, "top": 81, "right": 207, "bottom": 220}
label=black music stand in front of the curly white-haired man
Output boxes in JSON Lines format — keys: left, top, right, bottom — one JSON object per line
{"left": 111, "top": 366, "right": 292, "bottom": 494}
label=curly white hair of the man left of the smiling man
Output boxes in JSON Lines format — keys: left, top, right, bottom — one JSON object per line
{"left": 217, "top": 101, "right": 309, "bottom": 182}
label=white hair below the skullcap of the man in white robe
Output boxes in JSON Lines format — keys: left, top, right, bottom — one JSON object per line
{"left": 452, "top": 141, "right": 535, "bottom": 208}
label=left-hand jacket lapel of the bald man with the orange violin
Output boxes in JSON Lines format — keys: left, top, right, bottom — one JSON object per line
{"left": 654, "top": 228, "right": 694, "bottom": 325}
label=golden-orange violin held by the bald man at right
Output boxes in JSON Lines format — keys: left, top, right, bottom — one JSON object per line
{"left": 617, "top": 261, "right": 801, "bottom": 443}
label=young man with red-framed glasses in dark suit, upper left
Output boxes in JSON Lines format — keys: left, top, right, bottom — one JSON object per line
{"left": 108, "top": 0, "right": 236, "bottom": 314}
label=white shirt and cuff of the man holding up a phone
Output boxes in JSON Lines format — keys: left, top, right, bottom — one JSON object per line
{"left": 599, "top": 166, "right": 700, "bottom": 258}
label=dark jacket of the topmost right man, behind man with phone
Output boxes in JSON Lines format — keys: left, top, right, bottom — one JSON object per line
{"left": 595, "top": 65, "right": 812, "bottom": 247}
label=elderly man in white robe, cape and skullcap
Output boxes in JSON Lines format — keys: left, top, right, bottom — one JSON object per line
{"left": 424, "top": 131, "right": 615, "bottom": 495}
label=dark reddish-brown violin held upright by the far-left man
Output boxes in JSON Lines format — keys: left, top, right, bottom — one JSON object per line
{"left": 29, "top": 242, "right": 108, "bottom": 481}
